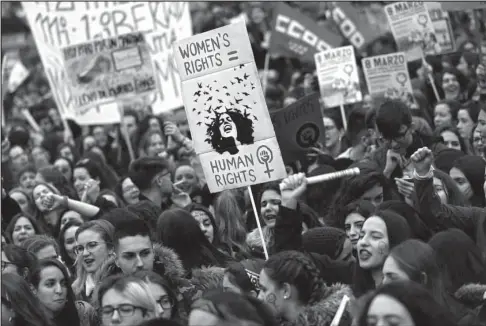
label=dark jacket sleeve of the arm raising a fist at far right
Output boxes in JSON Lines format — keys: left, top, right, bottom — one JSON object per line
{"left": 414, "top": 179, "right": 486, "bottom": 261}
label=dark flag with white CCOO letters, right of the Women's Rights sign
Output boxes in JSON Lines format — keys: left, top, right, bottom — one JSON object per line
{"left": 269, "top": 2, "right": 342, "bottom": 63}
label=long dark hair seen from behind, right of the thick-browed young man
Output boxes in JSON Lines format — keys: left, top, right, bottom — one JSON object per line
{"left": 156, "top": 209, "right": 232, "bottom": 273}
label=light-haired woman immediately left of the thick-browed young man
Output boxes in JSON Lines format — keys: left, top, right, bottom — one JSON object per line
{"left": 72, "top": 220, "right": 115, "bottom": 302}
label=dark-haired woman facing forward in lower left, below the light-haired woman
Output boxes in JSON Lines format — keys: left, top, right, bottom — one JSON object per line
{"left": 30, "top": 259, "right": 82, "bottom": 326}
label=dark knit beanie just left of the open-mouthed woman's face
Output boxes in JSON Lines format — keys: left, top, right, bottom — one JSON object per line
{"left": 302, "top": 227, "right": 347, "bottom": 259}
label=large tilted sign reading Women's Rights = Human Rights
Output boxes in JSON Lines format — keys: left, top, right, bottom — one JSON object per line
{"left": 174, "top": 22, "right": 286, "bottom": 192}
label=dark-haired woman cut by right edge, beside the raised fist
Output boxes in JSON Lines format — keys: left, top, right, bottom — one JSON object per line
{"left": 449, "top": 155, "right": 486, "bottom": 207}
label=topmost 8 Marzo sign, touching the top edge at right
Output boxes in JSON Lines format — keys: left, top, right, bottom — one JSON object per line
{"left": 385, "top": 1, "right": 441, "bottom": 61}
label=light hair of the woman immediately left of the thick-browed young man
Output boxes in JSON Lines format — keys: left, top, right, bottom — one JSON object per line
{"left": 72, "top": 220, "right": 115, "bottom": 295}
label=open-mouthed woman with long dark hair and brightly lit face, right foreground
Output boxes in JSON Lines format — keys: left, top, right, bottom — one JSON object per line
{"left": 353, "top": 210, "right": 411, "bottom": 297}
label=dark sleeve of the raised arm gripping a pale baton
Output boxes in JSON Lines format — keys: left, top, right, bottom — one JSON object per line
{"left": 274, "top": 206, "right": 303, "bottom": 253}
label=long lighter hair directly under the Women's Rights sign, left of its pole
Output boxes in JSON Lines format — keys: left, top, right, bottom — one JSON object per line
{"left": 214, "top": 190, "right": 250, "bottom": 258}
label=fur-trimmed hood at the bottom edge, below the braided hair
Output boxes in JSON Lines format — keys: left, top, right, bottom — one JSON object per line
{"left": 281, "top": 284, "right": 354, "bottom": 326}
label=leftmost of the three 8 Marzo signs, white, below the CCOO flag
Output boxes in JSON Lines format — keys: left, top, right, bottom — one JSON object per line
{"left": 315, "top": 45, "right": 362, "bottom": 108}
